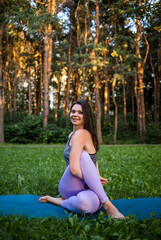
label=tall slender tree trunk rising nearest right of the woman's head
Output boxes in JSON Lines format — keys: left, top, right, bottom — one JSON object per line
{"left": 92, "top": 0, "right": 103, "bottom": 144}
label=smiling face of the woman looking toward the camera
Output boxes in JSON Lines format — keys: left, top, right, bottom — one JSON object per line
{"left": 70, "top": 104, "right": 84, "bottom": 128}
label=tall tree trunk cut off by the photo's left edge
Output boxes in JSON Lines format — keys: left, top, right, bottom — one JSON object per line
{"left": 0, "top": 26, "right": 5, "bottom": 143}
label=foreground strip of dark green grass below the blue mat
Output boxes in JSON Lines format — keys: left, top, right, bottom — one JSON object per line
{"left": 0, "top": 216, "right": 161, "bottom": 240}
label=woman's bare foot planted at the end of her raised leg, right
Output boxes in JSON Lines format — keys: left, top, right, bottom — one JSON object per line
{"left": 103, "top": 200, "right": 125, "bottom": 219}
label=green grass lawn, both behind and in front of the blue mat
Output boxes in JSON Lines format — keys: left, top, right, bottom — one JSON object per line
{"left": 0, "top": 145, "right": 161, "bottom": 240}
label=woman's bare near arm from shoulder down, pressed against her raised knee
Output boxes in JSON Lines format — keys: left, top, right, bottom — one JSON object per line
{"left": 69, "top": 129, "right": 89, "bottom": 179}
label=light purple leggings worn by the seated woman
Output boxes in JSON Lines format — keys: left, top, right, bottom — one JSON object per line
{"left": 59, "top": 151, "right": 108, "bottom": 214}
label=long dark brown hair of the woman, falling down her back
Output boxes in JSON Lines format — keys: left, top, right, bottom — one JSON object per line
{"left": 70, "top": 100, "right": 99, "bottom": 152}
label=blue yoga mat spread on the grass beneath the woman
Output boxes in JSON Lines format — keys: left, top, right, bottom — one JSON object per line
{"left": 0, "top": 195, "right": 161, "bottom": 220}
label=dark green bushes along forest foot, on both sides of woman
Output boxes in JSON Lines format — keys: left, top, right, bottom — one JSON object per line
{"left": 5, "top": 111, "right": 161, "bottom": 144}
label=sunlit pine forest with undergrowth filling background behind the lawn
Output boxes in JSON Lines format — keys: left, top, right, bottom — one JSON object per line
{"left": 0, "top": 0, "right": 161, "bottom": 144}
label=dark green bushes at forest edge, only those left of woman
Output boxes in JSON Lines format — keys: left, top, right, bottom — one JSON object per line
{"left": 5, "top": 115, "right": 72, "bottom": 144}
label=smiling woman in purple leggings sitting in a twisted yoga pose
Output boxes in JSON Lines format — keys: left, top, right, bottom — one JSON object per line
{"left": 39, "top": 100, "right": 124, "bottom": 219}
